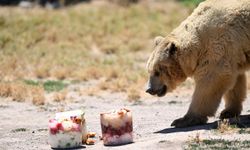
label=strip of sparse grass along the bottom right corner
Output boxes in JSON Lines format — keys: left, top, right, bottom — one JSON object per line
{"left": 185, "top": 139, "right": 250, "bottom": 150}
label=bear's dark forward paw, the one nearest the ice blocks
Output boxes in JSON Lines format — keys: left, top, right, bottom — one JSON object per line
{"left": 171, "top": 115, "right": 207, "bottom": 128}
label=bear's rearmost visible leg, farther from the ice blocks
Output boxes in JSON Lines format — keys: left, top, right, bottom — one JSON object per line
{"left": 220, "top": 74, "right": 247, "bottom": 119}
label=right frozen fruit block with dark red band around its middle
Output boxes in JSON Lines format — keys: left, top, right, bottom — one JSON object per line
{"left": 100, "top": 108, "right": 133, "bottom": 145}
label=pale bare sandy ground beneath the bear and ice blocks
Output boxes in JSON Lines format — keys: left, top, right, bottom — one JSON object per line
{"left": 0, "top": 84, "right": 250, "bottom": 150}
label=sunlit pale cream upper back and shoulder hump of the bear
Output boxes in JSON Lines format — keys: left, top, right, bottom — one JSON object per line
{"left": 171, "top": 0, "right": 250, "bottom": 50}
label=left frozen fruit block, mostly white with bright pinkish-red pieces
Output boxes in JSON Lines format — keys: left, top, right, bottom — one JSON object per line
{"left": 49, "top": 110, "right": 87, "bottom": 148}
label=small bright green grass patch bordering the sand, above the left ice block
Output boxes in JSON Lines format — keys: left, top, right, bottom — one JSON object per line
{"left": 43, "top": 80, "right": 67, "bottom": 92}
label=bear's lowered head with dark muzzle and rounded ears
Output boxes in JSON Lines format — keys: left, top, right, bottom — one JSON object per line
{"left": 146, "top": 37, "right": 187, "bottom": 96}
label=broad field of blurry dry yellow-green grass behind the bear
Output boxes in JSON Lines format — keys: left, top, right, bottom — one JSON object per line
{"left": 0, "top": 1, "right": 195, "bottom": 105}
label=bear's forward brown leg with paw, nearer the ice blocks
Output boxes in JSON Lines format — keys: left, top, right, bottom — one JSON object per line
{"left": 171, "top": 73, "right": 234, "bottom": 127}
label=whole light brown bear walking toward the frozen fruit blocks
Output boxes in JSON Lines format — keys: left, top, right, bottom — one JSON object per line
{"left": 146, "top": 0, "right": 250, "bottom": 127}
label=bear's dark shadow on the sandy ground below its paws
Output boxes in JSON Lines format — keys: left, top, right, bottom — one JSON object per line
{"left": 154, "top": 115, "right": 250, "bottom": 134}
